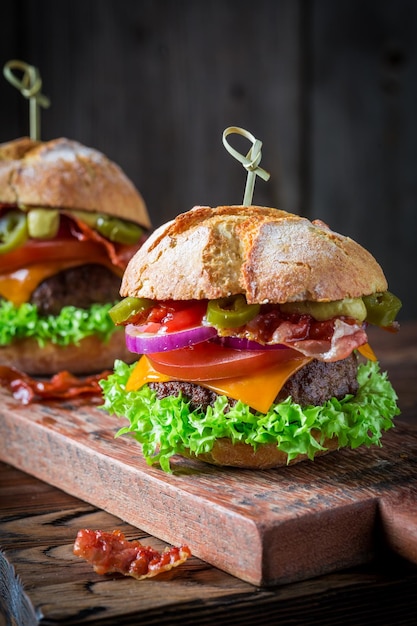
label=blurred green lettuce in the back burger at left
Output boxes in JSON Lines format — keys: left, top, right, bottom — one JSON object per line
{"left": 0, "top": 301, "right": 117, "bottom": 346}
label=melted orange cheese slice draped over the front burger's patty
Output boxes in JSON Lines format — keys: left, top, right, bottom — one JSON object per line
{"left": 126, "top": 350, "right": 313, "bottom": 413}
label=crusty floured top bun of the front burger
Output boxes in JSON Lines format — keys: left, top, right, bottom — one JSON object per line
{"left": 121, "top": 206, "right": 387, "bottom": 304}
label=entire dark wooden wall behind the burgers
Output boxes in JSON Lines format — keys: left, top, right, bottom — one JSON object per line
{"left": 0, "top": 0, "right": 417, "bottom": 319}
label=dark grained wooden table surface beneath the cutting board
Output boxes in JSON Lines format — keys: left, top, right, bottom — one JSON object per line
{"left": 0, "top": 322, "right": 417, "bottom": 626}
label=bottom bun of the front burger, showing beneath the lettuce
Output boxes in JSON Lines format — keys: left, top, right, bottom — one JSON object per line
{"left": 189, "top": 433, "right": 339, "bottom": 470}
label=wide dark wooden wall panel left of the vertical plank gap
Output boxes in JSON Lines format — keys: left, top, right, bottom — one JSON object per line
{"left": 0, "top": 0, "right": 300, "bottom": 226}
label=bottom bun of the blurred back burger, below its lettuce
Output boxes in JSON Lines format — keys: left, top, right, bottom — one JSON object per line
{"left": 0, "top": 330, "right": 137, "bottom": 376}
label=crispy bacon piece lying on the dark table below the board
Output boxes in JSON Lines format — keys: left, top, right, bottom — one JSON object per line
{"left": 74, "top": 528, "right": 191, "bottom": 580}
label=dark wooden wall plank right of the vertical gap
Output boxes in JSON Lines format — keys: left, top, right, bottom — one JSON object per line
{"left": 310, "top": 0, "right": 417, "bottom": 319}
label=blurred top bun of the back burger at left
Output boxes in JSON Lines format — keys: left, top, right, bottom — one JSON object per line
{"left": 0, "top": 137, "right": 151, "bottom": 228}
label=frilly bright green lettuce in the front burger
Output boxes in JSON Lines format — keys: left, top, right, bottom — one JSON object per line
{"left": 100, "top": 361, "right": 400, "bottom": 472}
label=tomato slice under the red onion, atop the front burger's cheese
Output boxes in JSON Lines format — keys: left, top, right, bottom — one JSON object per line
{"left": 147, "top": 341, "right": 290, "bottom": 381}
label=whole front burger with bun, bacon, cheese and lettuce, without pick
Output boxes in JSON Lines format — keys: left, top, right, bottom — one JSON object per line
{"left": 101, "top": 206, "right": 401, "bottom": 471}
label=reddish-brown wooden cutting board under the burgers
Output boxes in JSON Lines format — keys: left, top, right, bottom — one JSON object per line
{"left": 0, "top": 389, "right": 417, "bottom": 585}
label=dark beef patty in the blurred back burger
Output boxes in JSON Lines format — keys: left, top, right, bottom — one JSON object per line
{"left": 30, "top": 263, "right": 121, "bottom": 315}
